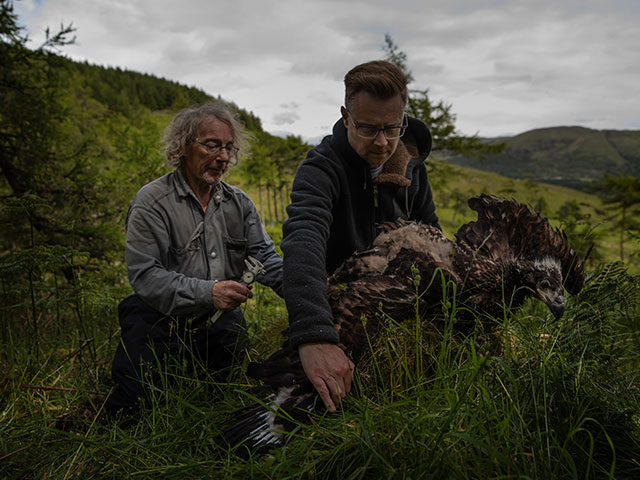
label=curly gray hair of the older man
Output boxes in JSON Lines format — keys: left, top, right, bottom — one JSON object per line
{"left": 163, "top": 100, "right": 249, "bottom": 168}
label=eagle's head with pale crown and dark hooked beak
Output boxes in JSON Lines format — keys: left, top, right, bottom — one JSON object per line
{"left": 520, "top": 257, "right": 564, "bottom": 320}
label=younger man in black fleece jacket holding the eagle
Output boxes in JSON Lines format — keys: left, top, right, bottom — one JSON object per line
{"left": 281, "top": 61, "right": 439, "bottom": 411}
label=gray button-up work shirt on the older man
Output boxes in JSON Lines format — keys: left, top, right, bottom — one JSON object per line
{"left": 125, "top": 169, "right": 282, "bottom": 315}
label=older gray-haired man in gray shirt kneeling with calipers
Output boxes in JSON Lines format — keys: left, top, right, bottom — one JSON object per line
{"left": 106, "top": 102, "right": 282, "bottom": 413}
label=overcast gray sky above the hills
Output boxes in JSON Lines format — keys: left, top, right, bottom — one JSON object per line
{"left": 15, "top": 0, "right": 640, "bottom": 139}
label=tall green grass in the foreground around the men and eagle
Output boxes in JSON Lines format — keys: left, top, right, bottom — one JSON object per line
{"left": 0, "top": 256, "right": 640, "bottom": 479}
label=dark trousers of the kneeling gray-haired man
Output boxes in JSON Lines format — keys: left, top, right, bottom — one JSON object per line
{"left": 105, "top": 294, "right": 249, "bottom": 413}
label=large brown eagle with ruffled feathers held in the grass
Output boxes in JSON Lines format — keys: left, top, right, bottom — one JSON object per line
{"left": 222, "top": 194, "right": 584, "bottom": 457}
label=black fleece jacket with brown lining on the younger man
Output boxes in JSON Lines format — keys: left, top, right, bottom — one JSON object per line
{"left": 281, "top": 118, "right": 440, "bottom": 348}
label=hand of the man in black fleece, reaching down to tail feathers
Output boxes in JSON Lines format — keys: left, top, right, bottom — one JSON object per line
{"left": 298, "top": 343, "right": 354, "bottom": 412}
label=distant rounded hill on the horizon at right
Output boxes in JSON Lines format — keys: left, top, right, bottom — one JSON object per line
{"left": 446, "top": 127, "right": 640, "bottom": 189}
